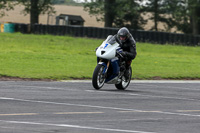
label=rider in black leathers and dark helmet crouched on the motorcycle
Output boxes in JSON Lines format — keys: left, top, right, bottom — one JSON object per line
{"left": 115, "top": 27, "right": 137, "bottom": 78}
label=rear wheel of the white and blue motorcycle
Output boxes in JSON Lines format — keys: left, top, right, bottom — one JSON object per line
{"left": 115, "top": 67, "right": 132, "bottom": 90}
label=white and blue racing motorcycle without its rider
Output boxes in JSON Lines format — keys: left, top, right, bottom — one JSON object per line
{"left": 92, "top": 35, "right": 132, "bottom": 90}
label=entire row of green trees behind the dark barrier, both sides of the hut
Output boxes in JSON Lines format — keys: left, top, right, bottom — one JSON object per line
{"left": 0, "top": 0, "right": 200, "bottom": 35}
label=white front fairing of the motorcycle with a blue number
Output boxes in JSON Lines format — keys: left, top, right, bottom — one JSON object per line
{"left": 96, "top": 36, "right": 119, "bottom": 60}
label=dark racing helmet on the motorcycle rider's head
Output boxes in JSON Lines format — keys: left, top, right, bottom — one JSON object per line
{"left": 117, "top": 27, "right": 130, "bottom": 43}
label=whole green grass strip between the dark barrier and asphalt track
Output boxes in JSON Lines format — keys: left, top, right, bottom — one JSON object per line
{"left": 0, "top": 33, "right": 200, "bottom": 80}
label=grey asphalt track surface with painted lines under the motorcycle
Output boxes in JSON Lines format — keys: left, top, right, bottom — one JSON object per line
{"left": 0, "top": 81, "right": 200, "bottom": 133}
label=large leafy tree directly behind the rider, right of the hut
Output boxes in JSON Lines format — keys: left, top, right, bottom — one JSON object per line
{"left": 84, "top": 0, "right": 145, "bottom": 29}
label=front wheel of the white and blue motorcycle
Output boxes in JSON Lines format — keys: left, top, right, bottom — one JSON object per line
{"left": 92, "top": 64, "right": 106, "bottom": 90}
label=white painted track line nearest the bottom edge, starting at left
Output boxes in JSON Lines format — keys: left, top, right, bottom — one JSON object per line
{"left": 0, "top": 120, "right": 155, "bottom": 133}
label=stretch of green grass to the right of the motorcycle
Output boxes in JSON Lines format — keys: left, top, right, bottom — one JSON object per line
{"left": 133, "top": 43, "right": 200, "bottom": 79}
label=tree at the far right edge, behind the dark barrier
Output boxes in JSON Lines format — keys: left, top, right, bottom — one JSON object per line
{"left": 165, "top": 0, "right": 200, "bottom": 35}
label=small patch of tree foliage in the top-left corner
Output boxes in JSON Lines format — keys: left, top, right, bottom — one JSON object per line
{"left": 0, "top": 0, "right": 14, "bottom": 18}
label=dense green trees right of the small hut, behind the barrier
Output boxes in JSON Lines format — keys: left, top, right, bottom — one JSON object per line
{"left": 84, "top": 0, "right": 200, "bottom": 35}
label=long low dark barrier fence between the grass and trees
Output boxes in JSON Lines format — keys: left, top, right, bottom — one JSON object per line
{"left": 16, "top": 24, "right": 200, "bottom": 46}
